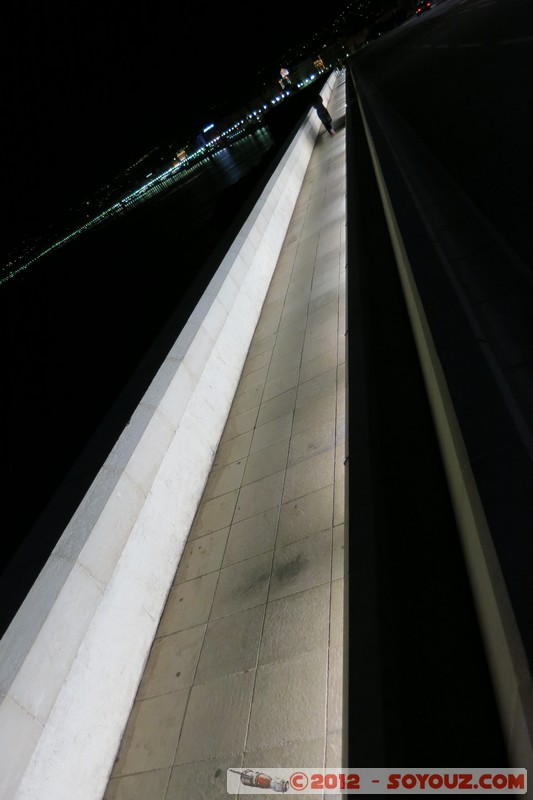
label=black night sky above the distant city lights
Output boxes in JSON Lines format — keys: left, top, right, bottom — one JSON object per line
{"left": 0, "top": 0, "right": 360, "bottom": 262}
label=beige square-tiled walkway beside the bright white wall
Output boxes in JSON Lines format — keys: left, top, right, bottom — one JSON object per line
{"left": 104, "top": 76, "right": 345, "bottom": 800}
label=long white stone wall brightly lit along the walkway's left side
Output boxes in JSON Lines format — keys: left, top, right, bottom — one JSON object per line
{"left": 0, "top": 75, "right": 336, "bottom": 800}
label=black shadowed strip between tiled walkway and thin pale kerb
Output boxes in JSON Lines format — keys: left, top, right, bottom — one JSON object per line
{"left": 343, "top": 64, "right": 507, "bottom": 780}
